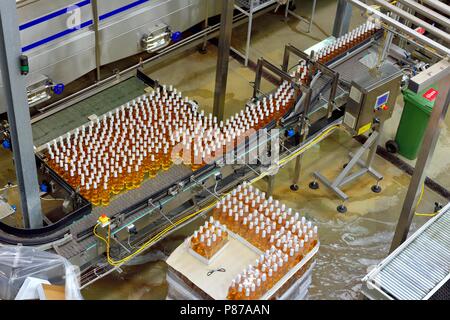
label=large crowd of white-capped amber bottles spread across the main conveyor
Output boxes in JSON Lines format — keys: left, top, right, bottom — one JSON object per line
{"left": 46, "top": 82, "right": 295, "bottom": 206}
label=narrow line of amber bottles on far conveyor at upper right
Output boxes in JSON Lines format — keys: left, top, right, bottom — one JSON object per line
{"left": 291, "top": 21, "right": 380, "bottom": 84}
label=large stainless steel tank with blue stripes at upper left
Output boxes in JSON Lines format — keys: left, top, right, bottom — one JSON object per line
{"left": 0, "top": 0, "right": 220, "bottom": 113}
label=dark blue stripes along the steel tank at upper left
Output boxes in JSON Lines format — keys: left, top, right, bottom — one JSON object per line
{"left": 19, "top": 0, "right": 150, "bottom": 52}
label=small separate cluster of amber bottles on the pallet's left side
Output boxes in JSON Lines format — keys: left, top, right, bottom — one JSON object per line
{"left": 189, "top": 217, "right": 228, "bottom": 260}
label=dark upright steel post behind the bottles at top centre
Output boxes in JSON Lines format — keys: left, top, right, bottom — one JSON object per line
{"left": 213, "top": 0, "right": 234, "bottom": 120}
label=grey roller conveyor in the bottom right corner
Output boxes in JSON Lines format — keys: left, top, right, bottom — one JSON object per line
{"left": 364, "top": 204, "right": 450, "bottom": 300}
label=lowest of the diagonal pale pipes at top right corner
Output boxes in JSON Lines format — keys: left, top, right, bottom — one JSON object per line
{"left": 348, "top": 0, "right": 450, "bottom": 56}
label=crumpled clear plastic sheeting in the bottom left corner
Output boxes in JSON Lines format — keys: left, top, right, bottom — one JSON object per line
{"left": 0, "top": 246, "right": 83, "bottom": 300}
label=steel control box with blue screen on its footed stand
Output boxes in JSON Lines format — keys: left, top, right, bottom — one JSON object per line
{"left": 310, "top": 62, "right": 403, "bottom": 213}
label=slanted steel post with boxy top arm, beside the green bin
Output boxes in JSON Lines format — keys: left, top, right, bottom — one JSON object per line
{"left": 390, "top": 59, "right": 450, "bottom": 252}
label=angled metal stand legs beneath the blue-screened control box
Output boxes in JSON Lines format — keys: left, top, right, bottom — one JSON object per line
{"left": 313, "top": 131, "right": 383, "bottom": 201}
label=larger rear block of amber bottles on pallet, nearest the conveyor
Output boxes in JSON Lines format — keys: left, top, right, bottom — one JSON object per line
{"left": 213, "top": 184, "right": 318, "bottom": 254}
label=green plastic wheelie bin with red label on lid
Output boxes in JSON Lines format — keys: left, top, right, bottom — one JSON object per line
{"left": 395, "top": 86, "right": 438, "bottom": 160}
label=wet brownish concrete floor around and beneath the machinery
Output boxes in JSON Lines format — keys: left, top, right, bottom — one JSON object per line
{"left": 0, "top": 0, "right": 450, "bottom": 299}
